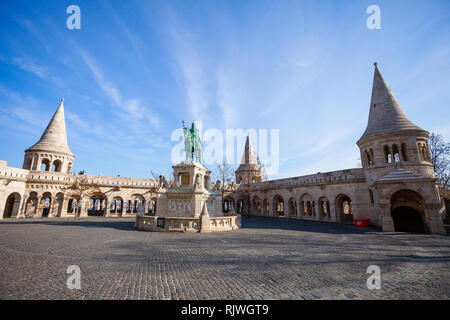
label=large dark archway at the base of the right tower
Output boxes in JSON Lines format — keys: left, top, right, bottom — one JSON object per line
{"left": 391, "top": 189, "right": 425, "bottom": 233}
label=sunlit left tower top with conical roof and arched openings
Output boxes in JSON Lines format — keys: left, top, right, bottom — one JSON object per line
{"left": 23, "top": 99, "right": 75, "bottom": 173}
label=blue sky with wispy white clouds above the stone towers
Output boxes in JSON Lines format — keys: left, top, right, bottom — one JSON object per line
{"left": 0, "top": 0, "right": 450, "bottom": 178}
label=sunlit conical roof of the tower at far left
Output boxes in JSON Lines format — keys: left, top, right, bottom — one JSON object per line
{"left": 27, "top": 99, "right": 73, "bottom": 155}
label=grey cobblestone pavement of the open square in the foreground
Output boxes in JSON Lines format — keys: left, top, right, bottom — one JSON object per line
{"left": 0, "top": 218, "right": 450, "bottom": 299}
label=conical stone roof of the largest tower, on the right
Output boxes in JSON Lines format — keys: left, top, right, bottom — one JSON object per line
{"left": 360, "top": 62, "right": 424, "bottom": 139}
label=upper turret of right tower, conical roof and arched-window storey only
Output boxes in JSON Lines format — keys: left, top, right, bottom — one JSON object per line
{"left": 357, "top": 63, "right": 434, "bottom": 179}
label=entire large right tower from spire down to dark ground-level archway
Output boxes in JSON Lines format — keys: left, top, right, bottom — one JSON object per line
{"left": 357, "top": 63, "right": 444, "bottom": 233}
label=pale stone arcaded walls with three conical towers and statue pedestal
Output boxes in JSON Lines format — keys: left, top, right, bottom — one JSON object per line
{"left": 0, "top": 64, "right": 445, "bottom": 234}
